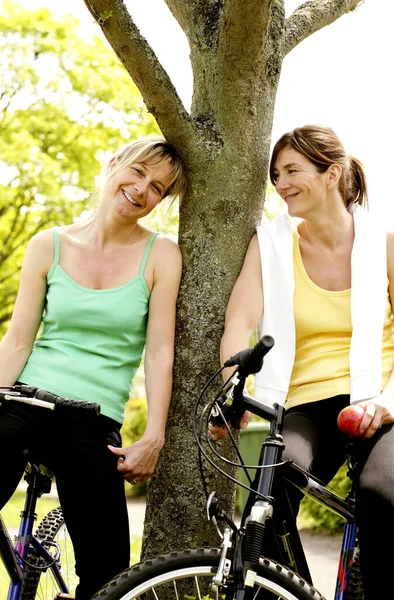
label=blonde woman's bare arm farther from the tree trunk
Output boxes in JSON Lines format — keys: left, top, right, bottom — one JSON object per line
{"left": 0, "top": 230, "right": 53, "bottom": 385}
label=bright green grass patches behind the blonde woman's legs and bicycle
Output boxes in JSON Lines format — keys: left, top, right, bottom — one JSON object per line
{"left": 0, "top": 490, "right": 141, "bottom": 600}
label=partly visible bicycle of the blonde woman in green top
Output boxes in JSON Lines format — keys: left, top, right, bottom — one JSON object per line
{"left": 0, "top": 384, "right": 100, "bottom": 600}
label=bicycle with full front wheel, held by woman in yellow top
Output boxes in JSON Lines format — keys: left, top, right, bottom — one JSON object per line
{"left": 92, "top": 336, "right": 363, "bottom": 600}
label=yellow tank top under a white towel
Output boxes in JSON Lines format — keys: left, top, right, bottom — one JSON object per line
{"left": 286, "top": 231, "right": 394, "bottom": 408}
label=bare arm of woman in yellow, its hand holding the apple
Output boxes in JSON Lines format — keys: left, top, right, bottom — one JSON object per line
{"left": 360, "top": 232, "right": 394, "bottom": 438}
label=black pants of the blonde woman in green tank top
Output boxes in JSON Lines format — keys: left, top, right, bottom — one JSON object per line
{"left": 0, "top": 402, "right": 130, "bottom": 600}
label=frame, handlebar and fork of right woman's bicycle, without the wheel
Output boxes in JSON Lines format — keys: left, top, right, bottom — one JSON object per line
{"left": 194, "top": 336, "right": 359, "bottom": 600}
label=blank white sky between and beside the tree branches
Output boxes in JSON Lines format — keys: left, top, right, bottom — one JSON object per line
{"left": 0, "top": 0, "right": 394, "bottom": 220}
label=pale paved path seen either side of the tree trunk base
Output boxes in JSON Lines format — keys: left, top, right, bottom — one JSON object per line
{"left": 128, "top": 499, "right": 342, "bottom": 600}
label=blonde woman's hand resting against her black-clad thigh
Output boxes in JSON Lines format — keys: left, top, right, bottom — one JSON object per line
{"left": 108, "top": 437, "right": 162, "bottom": 485}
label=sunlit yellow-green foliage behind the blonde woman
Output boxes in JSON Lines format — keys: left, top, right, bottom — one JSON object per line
{"left": 0, "top": 2, "right": 159, "bottom": 333}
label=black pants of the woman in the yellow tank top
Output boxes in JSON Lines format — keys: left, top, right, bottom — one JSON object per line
{"left": 245, "top": 395, "right": 394, "bottom": 600}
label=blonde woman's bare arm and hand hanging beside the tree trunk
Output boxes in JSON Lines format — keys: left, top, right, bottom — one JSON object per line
{"left": 111, "top": 239, "right": 182, "bottom": 483}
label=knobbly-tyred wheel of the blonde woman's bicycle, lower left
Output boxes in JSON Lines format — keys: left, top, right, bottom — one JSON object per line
{"left": 21, "top": 507, "right": 78, "bottom": 600}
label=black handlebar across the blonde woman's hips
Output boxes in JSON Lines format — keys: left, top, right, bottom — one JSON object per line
{"left": 0, "top": 383, "right": 100, "bottom": 416}
